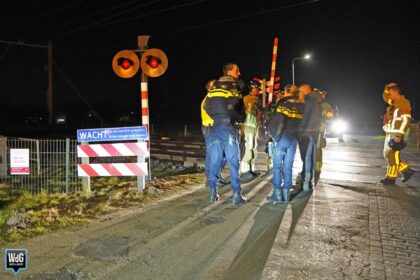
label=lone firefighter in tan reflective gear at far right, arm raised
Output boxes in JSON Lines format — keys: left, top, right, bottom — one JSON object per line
{"left": 380, "top": 83, "right": 414, "bottom": 186}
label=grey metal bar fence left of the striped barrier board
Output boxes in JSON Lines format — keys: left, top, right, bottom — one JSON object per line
{"left": 0, "top": 137, "right": 82, "bottom": 193}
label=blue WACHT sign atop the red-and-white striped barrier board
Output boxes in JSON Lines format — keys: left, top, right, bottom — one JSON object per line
{"left": 77, "top": 126, "right": 149, "bottom": 142}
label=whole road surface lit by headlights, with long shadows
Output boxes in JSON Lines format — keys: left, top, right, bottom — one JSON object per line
{"left": 0, "top": 137, "right": 420, "bottom": 279}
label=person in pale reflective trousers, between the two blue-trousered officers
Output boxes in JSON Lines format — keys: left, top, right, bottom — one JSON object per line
{"left": 241, "top": 80, "right": 260, "bottom": 177}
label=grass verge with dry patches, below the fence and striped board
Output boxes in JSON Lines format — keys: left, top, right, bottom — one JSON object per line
{"left": 0, "top": 173, "right": 205, "bottom": 247}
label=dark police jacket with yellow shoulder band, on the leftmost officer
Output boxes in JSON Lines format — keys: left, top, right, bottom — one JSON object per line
{"left": 203, "top": 87, "right": 243, "bottom": 125}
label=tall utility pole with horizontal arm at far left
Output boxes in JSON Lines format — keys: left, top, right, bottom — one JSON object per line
{"left": 0, "top": 40, "right": 53, "bottom": 126}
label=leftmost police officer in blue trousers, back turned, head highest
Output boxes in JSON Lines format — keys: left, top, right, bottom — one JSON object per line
{"left": 204, "top": 63, "right": 246, "bottom": 206}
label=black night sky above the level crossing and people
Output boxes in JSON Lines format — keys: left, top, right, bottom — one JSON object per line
{"left": 0, "top": 0, "right": 420, "bottom": 130}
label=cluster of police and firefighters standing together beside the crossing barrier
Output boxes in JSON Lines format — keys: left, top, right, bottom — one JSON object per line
{"left": 201, "top": 63, "right": 324, "bottom": 206}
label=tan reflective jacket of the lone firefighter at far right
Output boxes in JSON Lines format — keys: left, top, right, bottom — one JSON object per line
{"left": 383, "top": 93, "right": 411, "bottom": 137}
